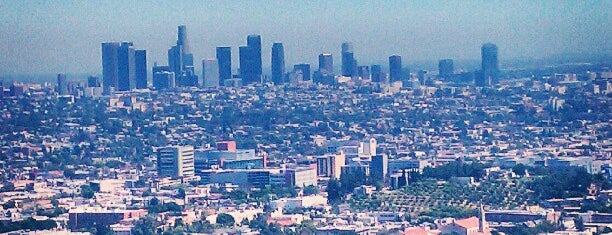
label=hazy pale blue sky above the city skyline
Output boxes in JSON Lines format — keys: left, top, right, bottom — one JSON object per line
{"left": 0, "top": 0, "right": 612, "bottom": 74}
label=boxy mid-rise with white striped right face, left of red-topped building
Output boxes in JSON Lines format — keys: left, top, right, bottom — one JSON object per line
{"left": 157, "top": 146, "right": 195, "bottom": 177}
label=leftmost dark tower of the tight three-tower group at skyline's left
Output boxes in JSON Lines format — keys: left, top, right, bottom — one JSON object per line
{"left": 102, "top": 42, "right": 121, "bottom": 94}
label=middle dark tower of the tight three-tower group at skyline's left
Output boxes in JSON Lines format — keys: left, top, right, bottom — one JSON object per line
{"left": 117, "top": 42, "right": 136, "bottom": 91}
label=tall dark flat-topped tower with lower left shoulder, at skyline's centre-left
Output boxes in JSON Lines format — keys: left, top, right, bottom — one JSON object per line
{"left": 238, "top": 35, "right": 262, "bottom": 84}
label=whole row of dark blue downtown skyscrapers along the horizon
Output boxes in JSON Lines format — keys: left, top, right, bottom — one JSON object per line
{"left": 102, "top": 25, "right": 499, "bottom": 94}
